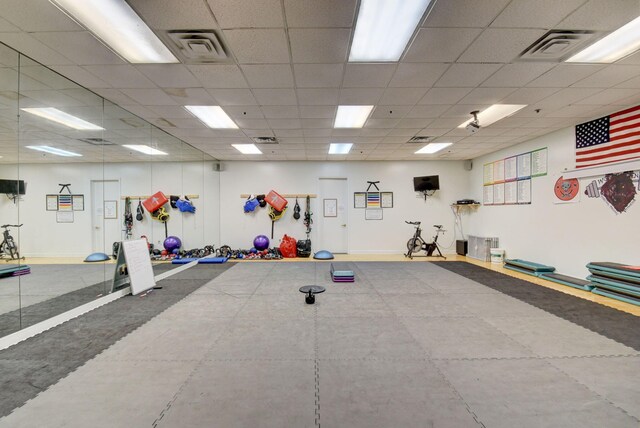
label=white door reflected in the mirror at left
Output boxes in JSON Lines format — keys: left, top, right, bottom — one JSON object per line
{"left": 91, "top": 180, "right": 124, "bottom": 254}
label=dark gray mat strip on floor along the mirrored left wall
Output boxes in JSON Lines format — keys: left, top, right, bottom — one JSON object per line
{"left": 0, "top": 264, "right": 233, "bottom": 417}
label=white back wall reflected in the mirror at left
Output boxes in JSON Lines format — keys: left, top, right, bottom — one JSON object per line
{"left": 0, "top": 162, "right": 219, "bottom": 257}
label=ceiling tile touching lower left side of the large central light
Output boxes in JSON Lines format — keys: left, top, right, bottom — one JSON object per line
{"left": 289, "top": 28, "right": 350, "bottom": 63}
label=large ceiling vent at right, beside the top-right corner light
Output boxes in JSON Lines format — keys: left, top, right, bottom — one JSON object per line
{"left": 519, "top": 30, "right": 596, "bottom": 62}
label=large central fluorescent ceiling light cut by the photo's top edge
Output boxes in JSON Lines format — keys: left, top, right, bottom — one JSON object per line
{"left": 349, "top": 0, "right": 431, "bottom": 62}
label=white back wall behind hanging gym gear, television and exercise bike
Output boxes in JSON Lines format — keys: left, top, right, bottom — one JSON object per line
{"left": 220, "top": 161, "right": 469, "bottom": 254}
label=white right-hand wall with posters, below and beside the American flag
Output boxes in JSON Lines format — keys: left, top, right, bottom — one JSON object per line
{"left": 465, "top": 127, "right": 640, "bottom": 278}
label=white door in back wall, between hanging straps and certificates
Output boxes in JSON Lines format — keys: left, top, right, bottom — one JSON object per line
{"left": 314, "top": 178, "right": 349, "bottom": 254}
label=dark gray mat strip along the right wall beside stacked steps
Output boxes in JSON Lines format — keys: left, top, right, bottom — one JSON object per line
{"left": 432, "top": 262, "right": 640, "bottom": 351}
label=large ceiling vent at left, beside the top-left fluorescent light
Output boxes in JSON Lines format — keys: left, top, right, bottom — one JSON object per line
{"left": 165, "top": 30, "right": 231, "bottom": 64}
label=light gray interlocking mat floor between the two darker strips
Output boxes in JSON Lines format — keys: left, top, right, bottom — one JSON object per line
{"left": 0, "top": 262, "right": 640, "bottom": 428}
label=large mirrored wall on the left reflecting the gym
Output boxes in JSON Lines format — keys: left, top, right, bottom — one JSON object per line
{"left": 0, "top": 45, "right": 219, "bottom": 337}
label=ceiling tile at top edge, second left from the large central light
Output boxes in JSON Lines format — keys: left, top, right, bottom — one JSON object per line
{"left": 207, "top": 0, "right": 284, "bottom": 29}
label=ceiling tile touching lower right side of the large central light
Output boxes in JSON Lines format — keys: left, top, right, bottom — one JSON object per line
{"left": 402, "top": 28, "right": 482, "bottom": 62}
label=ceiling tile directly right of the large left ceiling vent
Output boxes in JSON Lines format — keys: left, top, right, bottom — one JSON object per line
{"left": 224, "top": 29, "right": 289, "bottom": 64}
